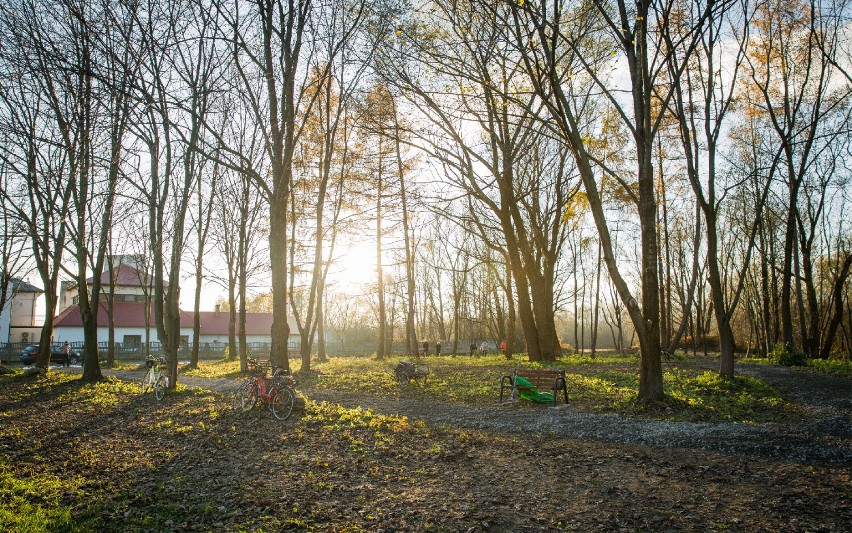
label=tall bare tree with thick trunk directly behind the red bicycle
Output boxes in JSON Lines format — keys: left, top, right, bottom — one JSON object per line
{"left": 208, "top": 0, "right": 319, "bottom": 368}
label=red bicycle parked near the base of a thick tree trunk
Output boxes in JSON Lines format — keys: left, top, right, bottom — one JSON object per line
{"left": 232, "top": 359, "right": 296, "bottom": 420}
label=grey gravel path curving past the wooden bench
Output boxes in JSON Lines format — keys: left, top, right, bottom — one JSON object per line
{"left": 105, "top": 365, "right": 852, "bottom": 466}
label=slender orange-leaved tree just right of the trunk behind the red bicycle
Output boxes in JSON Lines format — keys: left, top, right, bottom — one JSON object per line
{"left": 290, "top": 3, "right": 374, "bottom": 371}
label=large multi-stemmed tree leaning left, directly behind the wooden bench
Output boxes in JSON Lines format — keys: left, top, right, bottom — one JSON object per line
{"left": 379, "top": 2, "right": 575, "bottom": 360}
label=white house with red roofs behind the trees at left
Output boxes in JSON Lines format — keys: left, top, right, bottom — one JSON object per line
{"left": 53, "top": 259, "right": 298, "bottom": 346}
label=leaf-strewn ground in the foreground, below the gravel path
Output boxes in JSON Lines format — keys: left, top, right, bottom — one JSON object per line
{"left": 0, "top": 373, "right": 852, "bottom": 531}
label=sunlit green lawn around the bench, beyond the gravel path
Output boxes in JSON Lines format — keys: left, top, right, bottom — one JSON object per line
{"left": 186, "top": 351, "right": 808, "bottom": 423}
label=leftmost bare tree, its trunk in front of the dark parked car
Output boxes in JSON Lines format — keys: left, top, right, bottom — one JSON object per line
{"left": 0, "top": 2, "right": 84, "bottom": 370}
